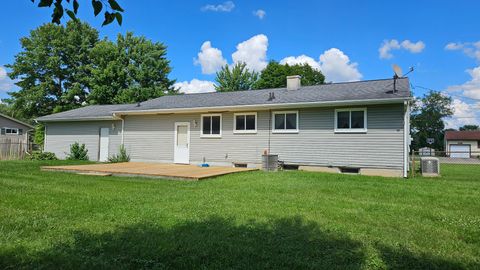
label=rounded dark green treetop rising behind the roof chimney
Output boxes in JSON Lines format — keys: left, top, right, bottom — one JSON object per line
{"left": 255, "top": 61, "right": 325, "bottom": 89}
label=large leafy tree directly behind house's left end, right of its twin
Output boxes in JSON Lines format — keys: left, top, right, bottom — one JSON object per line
{"left": 88, "top": 32, "right": 177, "bottom": 104}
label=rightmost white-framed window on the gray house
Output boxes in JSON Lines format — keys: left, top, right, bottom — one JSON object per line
{"left": 335, "top": 108, "right": 367, "bottom": 133}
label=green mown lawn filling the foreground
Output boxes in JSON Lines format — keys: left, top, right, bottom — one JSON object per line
{"left": 0, "top": 161, "right": 480, "bottom": 269}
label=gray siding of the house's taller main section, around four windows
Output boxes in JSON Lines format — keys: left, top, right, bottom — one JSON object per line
{"left": 122, "top": 104, "right": 404, "bottom": 169}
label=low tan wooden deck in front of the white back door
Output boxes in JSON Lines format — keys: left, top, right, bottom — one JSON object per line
{"left": 42, "top": 162, "right": 257, "bottom": 180}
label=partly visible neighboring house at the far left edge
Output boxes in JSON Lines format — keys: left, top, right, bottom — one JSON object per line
{"left": 0, "top": 113, "right": 33, "bottom": 143}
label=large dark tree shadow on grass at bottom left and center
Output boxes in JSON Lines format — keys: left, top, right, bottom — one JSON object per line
{"left": 0, "top": 217, "right": 365, "bottom": 269}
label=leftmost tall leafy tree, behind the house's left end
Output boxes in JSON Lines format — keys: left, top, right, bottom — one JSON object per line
{"left": 6, "top": 21, "right": 98, "bottom": 119}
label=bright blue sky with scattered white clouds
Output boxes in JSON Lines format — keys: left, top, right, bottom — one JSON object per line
{"left": 0, "top": 0, "right": 480, "bottom": 126}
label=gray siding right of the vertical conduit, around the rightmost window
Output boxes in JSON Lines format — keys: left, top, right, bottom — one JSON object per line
{"left": 271, "top": 105, "right": 403, "bottom": 169}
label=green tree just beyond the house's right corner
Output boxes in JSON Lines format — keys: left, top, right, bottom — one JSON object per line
{"left": 411, "top": 91, "right": 453, "bottom": 150}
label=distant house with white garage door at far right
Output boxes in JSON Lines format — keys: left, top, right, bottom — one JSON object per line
{"left": 445, "top": 131, "right": 480, "bottom": 158}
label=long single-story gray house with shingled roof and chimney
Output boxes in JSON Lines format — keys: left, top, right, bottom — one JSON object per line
{"left": 37, "top": 76, "right": 411, "bottom": 176}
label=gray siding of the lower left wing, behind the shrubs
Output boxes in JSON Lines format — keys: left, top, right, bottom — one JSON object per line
{"left": 44, "top": 121, "right": 122, "bottom": 161}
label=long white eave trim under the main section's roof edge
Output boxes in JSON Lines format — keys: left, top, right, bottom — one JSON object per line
{"left": 113, "top": 97, "right": 412, "bottom": 116}
